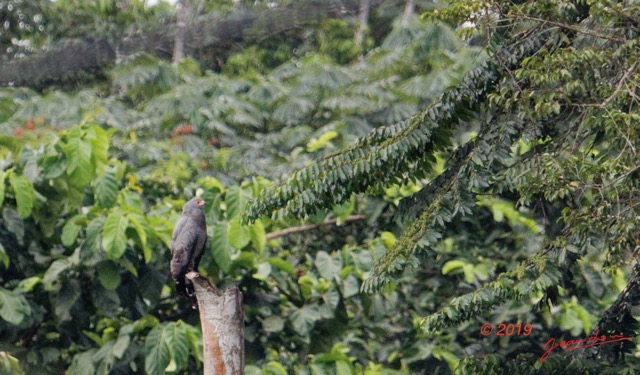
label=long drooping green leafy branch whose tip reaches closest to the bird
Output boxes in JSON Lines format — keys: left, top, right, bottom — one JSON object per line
{"left": 246, "top": 32, "right": 549, "bottom": 221}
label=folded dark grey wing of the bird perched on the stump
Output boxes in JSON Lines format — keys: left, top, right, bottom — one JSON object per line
{"left": 170, "top": 216, "right": 198, "bottom": 279}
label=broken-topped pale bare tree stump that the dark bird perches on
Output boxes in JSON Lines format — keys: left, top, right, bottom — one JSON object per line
{"left": 187, "top": 272, "right": 244, "bottom": 375}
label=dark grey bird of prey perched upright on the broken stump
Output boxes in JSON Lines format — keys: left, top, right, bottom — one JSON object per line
{"left": 170, "top": 198, "right": 207, "bottom": 308}
